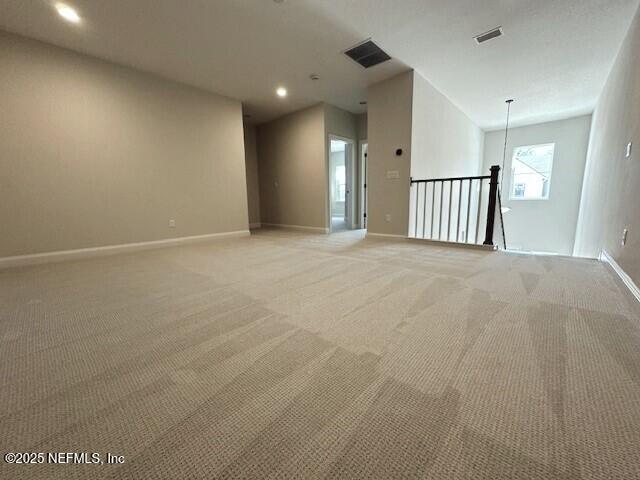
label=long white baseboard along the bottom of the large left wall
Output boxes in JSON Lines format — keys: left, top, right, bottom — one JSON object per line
{"left": 0, "top": 230, "right": 250, "bottom": 269}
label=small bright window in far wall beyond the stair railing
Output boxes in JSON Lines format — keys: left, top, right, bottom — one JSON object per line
{"left": 510, "top": 143, "right": 555, "bottom": 200}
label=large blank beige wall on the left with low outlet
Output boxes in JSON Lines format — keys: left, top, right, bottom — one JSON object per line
{"left": 0, "top": 32, "right": 248, "bottom": 257}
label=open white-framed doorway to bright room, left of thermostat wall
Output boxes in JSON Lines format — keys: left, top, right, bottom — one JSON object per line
{"left": 329, "top": 135, "right": 357, "bottom": 232}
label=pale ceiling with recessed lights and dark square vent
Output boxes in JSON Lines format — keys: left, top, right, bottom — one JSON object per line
{"left": 0, "top": 0, "right": 638, "bottom": 129}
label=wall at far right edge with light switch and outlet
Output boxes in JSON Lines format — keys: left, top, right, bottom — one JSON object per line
{"left": 574, "top": 5, "right": 640, "bottom": 284}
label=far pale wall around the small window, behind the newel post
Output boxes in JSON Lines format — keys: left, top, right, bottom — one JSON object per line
{"left": 484, "top": 115, "right": 591, "bottom": 255}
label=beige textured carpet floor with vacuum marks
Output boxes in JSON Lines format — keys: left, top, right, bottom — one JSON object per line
{"left": 0, "top": 230, "right": 640, "bottom": 480}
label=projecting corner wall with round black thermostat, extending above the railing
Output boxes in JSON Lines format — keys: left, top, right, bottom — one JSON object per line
{"left": 368, "top": 71, "right": 484, "bottom": 237}
